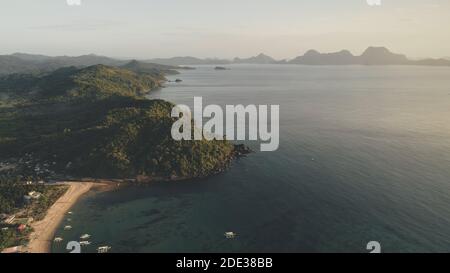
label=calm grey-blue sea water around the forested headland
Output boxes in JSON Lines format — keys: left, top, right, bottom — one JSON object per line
{"left": 52, "top": 65, "right": 450, "bottom": 253}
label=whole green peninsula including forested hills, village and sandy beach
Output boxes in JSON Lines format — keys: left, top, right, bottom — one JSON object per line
{"left": 0, "top": 61, "right": 248, "bottom": 252}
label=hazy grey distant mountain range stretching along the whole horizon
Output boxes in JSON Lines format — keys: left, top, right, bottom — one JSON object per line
{"left": 0, "top": 47, "right": 450, "bottom": 75}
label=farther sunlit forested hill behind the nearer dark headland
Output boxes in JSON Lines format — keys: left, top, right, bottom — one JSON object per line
{"left": 0, "top": 65, "right": 165, "bottom": 100}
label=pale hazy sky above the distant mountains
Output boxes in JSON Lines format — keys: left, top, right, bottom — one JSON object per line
{"left": 0, "top": 0, "right": 450, "bottom": 58}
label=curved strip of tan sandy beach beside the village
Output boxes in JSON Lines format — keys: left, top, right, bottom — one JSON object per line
{"left": 25, "top": 182, "right": 98, "bottom": 253}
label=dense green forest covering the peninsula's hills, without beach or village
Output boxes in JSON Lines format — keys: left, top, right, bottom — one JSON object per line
{"left": 0, "top": 62, "right": 234, "bottom": 179}
